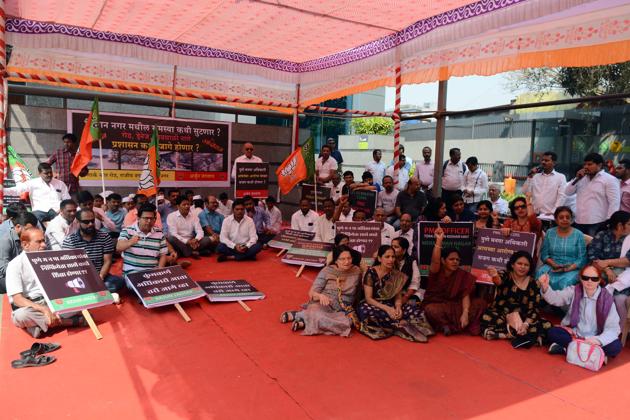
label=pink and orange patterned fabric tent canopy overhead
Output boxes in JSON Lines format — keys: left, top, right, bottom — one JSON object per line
{"left": 5, "top": 0, "right": 630, "bottom": 108}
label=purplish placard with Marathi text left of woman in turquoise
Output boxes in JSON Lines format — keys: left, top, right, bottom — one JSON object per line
{"left": 471, "top": 229, "right": 536, "bottom": 283}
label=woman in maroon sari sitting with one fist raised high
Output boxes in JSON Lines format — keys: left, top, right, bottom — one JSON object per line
{"left": 422, "top": 227, "right": 485, "bottom": 335}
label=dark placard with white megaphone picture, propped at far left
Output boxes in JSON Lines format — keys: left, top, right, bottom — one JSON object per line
{"left": 25, "top": 249, "right": 114, "bottom": 314}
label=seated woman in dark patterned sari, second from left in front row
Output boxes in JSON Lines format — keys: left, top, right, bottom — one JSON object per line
{"left": 357, "top": 245, "right": 433, "bottom": 343}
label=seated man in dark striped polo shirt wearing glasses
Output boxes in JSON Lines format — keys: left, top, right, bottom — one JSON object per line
{"left": 62, "top": 209, "right": 124, "bottom": 293}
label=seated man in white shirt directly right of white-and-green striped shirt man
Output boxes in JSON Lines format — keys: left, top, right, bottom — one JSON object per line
{"left": 166, "top": 195, "right": 212, "bottom": 258}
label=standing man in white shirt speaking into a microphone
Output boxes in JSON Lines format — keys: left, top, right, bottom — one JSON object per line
{"left": 522, "top": 152, "right": 567, "bottom": 218}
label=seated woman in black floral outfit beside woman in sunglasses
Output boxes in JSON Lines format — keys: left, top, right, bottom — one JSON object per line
{"left": 481, "top": 251, "right": 551, "bottom": 348}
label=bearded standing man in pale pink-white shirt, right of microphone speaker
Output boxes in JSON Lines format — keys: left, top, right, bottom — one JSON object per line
{"left": 565, "top": 153, "right": 620, "bottom": 236}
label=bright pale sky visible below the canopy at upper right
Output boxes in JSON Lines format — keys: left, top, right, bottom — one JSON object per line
{"left": 385, "top": 73, "right": 517, "bottom": 111}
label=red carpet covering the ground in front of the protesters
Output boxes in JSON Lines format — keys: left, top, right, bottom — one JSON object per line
{"left": 0, "top": 251, "right": 630, "bottom": 419}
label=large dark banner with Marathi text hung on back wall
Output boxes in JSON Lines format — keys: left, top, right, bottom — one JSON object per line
{"left": 68, "top": 110, "right": 231, "bottom": 188}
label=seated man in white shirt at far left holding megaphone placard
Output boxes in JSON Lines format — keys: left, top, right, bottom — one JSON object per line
{"left": 7, "top": 226, "right": 87, "bottom": 338}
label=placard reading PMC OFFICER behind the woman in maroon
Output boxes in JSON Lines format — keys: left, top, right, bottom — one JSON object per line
{"left": 417, "top": 222, "right": 473, "bottom": 276}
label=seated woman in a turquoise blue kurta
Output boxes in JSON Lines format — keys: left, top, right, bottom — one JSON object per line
{"left": 536, "top": 206, "right": 586, "bottom": 290}
